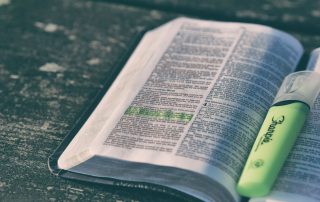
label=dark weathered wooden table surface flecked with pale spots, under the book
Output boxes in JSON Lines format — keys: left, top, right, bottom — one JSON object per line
{"left": 0, "top": 0, "right": 320, "bottom": 201}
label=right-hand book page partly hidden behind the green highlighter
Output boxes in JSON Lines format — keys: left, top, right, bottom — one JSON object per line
{"left": 251, "top": 49, "right": 320, "bottom": 202}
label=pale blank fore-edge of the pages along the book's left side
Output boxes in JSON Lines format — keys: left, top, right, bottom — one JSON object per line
{"left": 58, "top": 20, "right": 174, "bottom": 169}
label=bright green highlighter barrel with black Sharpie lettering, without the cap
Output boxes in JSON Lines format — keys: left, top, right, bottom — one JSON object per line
{"left": 237, "top": 101, "right": 309, "bottom": 197}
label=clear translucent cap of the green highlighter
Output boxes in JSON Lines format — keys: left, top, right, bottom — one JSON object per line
{"left": 273, "top": 71, "right": 320, "bottom": 107}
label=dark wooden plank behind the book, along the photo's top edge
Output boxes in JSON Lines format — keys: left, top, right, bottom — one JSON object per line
{"left": 106, "top": 0, "right": 320, "bottom": 34}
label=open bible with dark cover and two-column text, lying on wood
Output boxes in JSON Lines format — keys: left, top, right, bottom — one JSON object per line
{"left": 49, "top": 18, "right": 320, "bottom": 202}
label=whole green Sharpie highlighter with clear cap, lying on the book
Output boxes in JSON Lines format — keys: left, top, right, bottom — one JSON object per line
{"left": 236, "top": 71, "right": 320, "bottom": 197}
